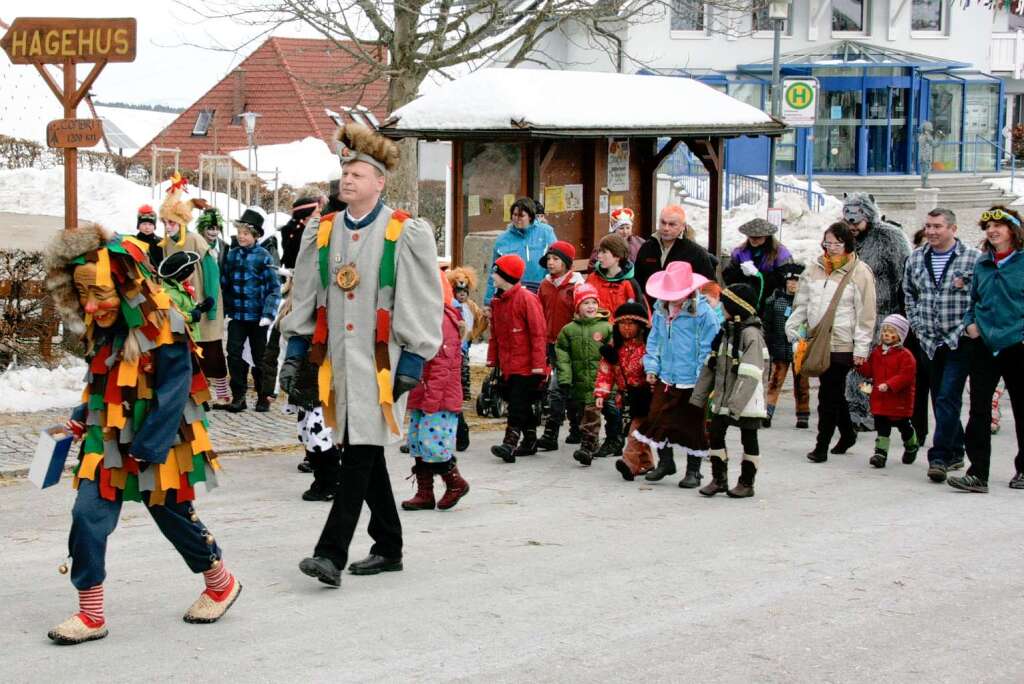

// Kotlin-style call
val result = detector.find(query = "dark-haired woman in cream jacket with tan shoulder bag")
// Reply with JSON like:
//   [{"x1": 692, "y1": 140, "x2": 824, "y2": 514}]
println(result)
[{"x1": 785, "y1": 221, "x2": 876, "y2": 463}]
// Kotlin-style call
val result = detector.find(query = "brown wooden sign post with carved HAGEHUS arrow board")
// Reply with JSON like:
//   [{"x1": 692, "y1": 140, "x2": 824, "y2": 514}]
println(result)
[{"x1": 0, "y1": 17, "x2": 136, "y2": 228}]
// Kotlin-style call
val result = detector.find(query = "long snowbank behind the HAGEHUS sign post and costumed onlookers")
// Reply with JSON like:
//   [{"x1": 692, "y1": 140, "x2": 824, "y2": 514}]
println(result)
[{"x1": 0, "y1": 166, "x2": 289, "y2": 240}]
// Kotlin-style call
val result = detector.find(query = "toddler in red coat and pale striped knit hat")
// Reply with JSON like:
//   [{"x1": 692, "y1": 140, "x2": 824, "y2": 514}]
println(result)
[{"x1": 857, "y1": 313, "x2": 920, "y2": 468}]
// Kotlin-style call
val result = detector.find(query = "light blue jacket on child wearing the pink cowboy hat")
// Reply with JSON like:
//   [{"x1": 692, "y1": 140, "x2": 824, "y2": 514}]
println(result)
[{"x1": 643, "y1": 295, "x2": 721, "y2": 387}]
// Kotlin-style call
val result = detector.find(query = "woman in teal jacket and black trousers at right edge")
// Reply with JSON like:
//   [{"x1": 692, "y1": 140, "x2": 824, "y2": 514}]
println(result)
[{"x1": 946, "y1": 207, "x2": 1024, "y2": 494}]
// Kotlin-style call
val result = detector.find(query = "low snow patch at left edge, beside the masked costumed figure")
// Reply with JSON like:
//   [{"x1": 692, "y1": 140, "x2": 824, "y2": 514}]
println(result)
[{"x1": 0, "y1": 358, "x2": 85, "y2": 414}]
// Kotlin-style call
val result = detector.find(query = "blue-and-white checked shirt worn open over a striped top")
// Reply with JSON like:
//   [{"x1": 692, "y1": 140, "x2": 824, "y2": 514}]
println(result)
[{"x1": 903, "y1": 240, "x2": 981, "y2": 358}]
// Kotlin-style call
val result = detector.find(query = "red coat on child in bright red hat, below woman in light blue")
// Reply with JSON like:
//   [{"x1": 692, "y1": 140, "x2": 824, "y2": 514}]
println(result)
[{"x1": 489, "y1": 284, "x2": 548, "y2": 378}]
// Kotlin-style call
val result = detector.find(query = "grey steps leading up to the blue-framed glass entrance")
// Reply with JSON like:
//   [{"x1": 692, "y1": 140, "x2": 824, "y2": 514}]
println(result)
[{"x1": 814, "y1": 173, "x2": 1024, "y2": 214}]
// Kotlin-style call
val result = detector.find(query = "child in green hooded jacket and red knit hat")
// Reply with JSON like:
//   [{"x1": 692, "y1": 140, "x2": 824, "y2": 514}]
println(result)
[{"x1": 555, "y1": 284, "x2": 611, "y2": 466}]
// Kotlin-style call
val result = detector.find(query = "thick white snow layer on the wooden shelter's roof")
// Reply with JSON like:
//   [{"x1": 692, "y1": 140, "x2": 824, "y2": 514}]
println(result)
[{"x1": 385, "y1": 69, "x2": 783, "y2": 137}]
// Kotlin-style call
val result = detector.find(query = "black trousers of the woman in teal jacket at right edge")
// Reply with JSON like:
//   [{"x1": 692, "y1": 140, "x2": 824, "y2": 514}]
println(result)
[{"x1": 964, "y1": 340, "x2": 1024, "y2": 482}]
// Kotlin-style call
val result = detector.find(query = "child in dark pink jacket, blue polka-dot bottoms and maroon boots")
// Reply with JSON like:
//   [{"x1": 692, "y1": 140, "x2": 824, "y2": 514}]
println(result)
[{"x1": 401, "y1": 274, "x2": 469, "y2": 511}]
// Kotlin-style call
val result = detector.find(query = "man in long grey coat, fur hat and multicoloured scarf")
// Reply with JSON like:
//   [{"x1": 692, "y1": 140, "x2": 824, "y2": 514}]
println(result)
[{"x1": 281, "y1": 124, "x2": 443, "y2": 587}]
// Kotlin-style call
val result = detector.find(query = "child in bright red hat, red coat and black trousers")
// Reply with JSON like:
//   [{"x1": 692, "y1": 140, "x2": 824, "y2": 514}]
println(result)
[{"x1": 487, "y1": 254, "x2": 548, "y2": 463}]
